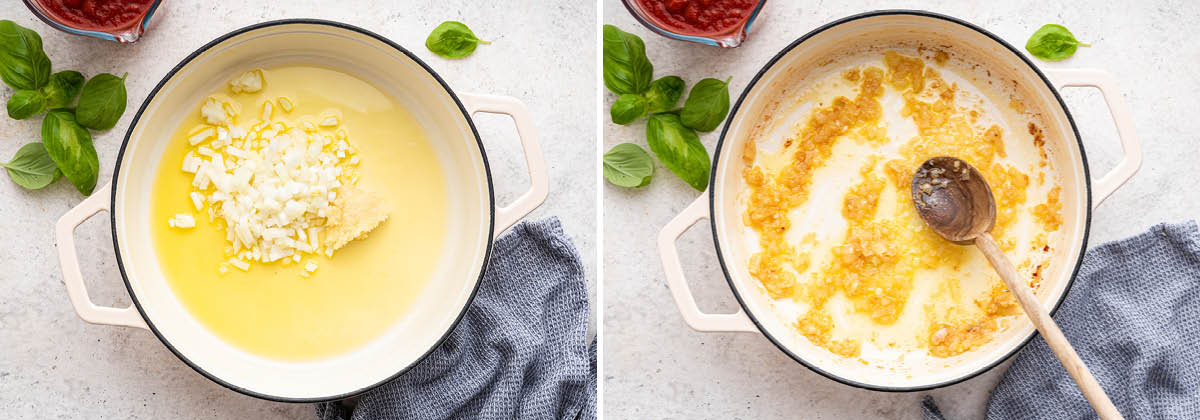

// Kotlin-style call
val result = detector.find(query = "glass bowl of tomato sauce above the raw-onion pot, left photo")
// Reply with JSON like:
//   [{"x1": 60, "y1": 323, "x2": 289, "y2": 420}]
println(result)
[{"x1": 25, "y1": 0, "x2": 162, "y2": 43}]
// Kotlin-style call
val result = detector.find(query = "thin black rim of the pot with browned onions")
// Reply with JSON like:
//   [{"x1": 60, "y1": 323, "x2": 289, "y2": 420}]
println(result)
[{"x1": 708, "y1": 10, "x2": 1092, "y2": 392}]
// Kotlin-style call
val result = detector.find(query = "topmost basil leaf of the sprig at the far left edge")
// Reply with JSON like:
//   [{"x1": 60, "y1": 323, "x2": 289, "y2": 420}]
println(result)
[{"x1": 0, "y1": 20, "x2": 50, "y2": 90}]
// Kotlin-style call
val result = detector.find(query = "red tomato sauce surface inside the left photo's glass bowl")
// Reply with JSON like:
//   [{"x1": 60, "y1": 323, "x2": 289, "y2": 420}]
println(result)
[{"x1": 37, "y1": 0, "x2": 155, "y2": 29}]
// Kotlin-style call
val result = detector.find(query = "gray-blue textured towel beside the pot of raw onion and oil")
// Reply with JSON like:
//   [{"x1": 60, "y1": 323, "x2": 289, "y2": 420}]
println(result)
[{"x1": 317, "y1": 217, "x2": 596, "y2": 420}]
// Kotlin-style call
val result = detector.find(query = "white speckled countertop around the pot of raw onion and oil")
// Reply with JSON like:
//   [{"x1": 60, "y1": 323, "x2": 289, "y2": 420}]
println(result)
[{"x1": 0, "y1": 0, "x2": 596, "y2": 419}]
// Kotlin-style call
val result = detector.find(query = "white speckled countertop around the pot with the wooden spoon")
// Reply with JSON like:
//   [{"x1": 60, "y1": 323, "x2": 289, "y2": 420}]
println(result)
[{"x1": 601, "y1": 0, "x2": 1200, "y2": 419}]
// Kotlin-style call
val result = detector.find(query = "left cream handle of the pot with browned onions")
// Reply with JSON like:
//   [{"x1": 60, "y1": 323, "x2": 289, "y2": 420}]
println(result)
[{"x1": 659, "y1": 194, "x2": 758, "y2": 332}]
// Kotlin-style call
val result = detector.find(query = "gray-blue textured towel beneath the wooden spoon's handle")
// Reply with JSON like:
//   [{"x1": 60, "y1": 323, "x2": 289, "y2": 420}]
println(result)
[{"x1": 922, "y1": 222, "x2": 1200, "y2": 419}]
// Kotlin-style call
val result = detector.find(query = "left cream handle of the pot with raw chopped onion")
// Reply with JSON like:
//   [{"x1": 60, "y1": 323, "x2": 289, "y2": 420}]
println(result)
[{"x1": 54, "y1": 184, "x2": 149, "y2": 330}]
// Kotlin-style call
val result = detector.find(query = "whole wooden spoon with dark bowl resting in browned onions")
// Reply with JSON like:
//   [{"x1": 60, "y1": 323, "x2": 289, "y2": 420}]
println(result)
[{"x1": 912, "y1": 157, "x2": 1122, "y2": 419}]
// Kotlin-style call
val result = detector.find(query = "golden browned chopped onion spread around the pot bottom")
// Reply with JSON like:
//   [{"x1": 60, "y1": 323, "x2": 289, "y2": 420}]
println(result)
[{"x1": 742, "y1": 52, "x2": 1062, "y2": 358}]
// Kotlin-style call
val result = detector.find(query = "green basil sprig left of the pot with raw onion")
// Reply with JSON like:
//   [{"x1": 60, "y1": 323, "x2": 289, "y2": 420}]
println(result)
[{"x1": 0, "y1": 20, "x2": 127, "y2": 196}]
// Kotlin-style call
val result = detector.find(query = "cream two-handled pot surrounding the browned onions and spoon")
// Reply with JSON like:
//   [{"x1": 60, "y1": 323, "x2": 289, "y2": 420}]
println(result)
[{"x1": 659, "y1": 11, "x2": 1141, "y2": 391}]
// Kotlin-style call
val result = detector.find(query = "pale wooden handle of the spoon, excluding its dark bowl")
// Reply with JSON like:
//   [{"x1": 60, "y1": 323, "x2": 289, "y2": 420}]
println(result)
[{"x1": 976, "y1": 233, "x2": 1123, "y2": 419}]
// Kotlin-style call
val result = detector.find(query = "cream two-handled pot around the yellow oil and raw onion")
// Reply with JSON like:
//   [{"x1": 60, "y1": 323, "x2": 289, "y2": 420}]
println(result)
[{"x1": 56, "y1": 19, "x2": 548, "y2": 402}]
